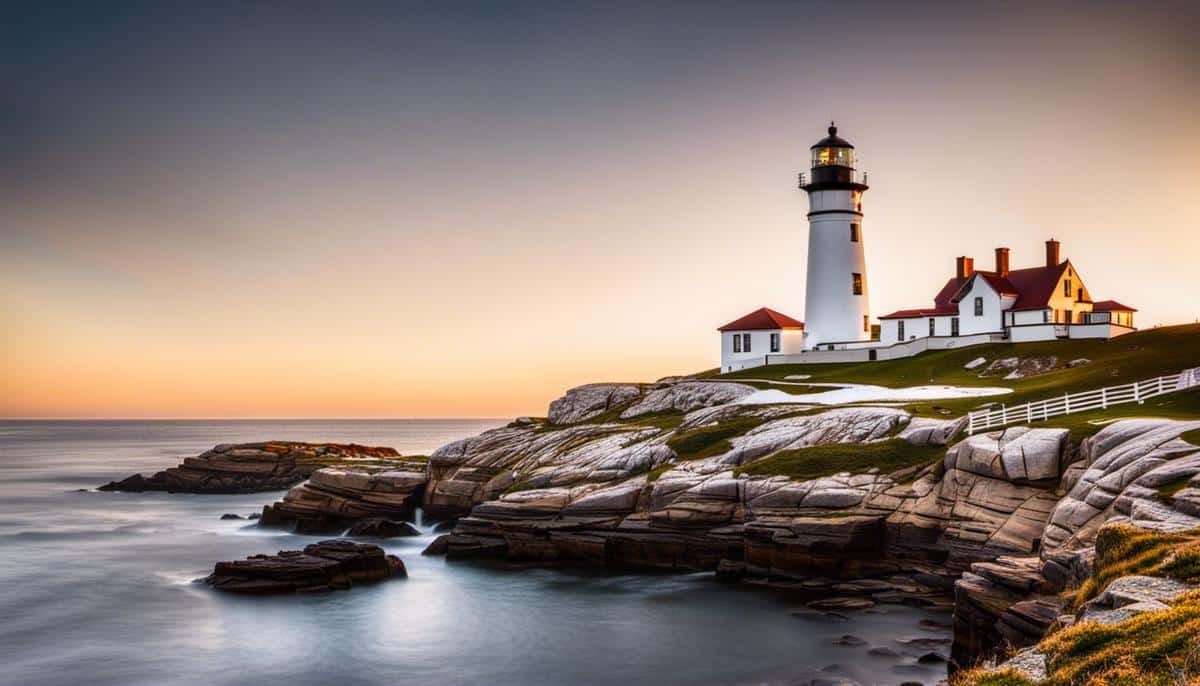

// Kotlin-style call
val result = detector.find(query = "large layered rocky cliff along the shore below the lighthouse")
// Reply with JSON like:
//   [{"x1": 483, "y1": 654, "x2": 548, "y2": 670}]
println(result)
[{"x1": 229, "y1": 380, "x2": 1200, "y2": 667}]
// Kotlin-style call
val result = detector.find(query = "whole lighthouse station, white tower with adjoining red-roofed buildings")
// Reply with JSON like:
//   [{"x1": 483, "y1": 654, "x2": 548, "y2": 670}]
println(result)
[{"x1": 719, "y1": 124, "x2": 1136, "y2": 372}]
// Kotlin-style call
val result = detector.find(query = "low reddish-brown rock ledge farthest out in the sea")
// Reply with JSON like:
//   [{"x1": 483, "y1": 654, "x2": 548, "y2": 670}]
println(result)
[{"x1": 100, "y1": 441, "x2": 400, "y2": 493}]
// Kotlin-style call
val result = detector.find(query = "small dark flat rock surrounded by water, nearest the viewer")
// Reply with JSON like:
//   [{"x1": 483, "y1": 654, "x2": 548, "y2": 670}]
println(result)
[{"x1": 203, "y1": 541, "x2": 408, "y2": 595}]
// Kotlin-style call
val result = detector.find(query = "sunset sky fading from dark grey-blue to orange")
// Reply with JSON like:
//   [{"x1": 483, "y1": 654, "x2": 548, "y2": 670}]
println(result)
[{"x1": 0, "y1": 1, "x2": 1200, "y2": 417}]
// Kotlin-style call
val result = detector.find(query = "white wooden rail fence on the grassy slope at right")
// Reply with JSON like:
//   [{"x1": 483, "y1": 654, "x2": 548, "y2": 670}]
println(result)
[{"x1": 967, "y1": 367, "x2": 1200, "y2": 434}]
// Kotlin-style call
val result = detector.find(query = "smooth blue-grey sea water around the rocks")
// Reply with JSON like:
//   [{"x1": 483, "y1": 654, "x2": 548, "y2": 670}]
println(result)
[{"x1": 0, "y1": 420, "x2": 948, "y2": 686}]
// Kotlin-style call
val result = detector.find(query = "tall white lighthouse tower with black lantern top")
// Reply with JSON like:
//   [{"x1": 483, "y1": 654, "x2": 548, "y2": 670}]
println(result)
[{"x1": 800, "y1": 122, "x2": 871, "y2": 350}]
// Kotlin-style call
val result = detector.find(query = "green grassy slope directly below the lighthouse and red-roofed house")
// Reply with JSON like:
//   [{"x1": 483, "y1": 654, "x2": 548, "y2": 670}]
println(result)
[{"x1": 716, "y1": 324, "x2": 1200, "y2": 414}]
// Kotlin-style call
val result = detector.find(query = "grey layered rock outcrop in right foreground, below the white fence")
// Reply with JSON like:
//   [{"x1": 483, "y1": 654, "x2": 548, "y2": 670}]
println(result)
[{"x1": 954, "y1": 420, "x2": 1200, "y2": 680}]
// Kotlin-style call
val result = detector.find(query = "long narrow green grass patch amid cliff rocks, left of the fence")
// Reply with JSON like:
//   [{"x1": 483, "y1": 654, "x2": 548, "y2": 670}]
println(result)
[{"x1": 734, "y1": 439, "x2": 946, "y2": 480}]
